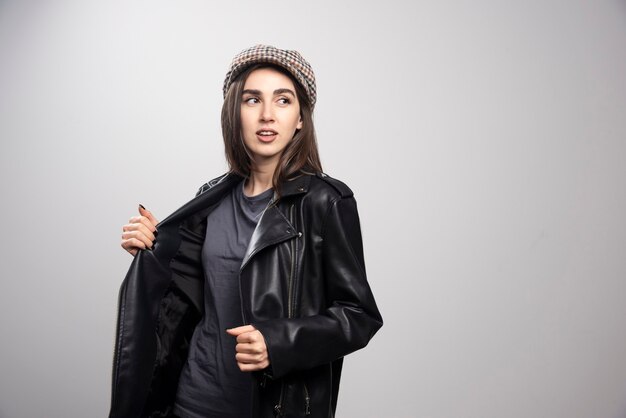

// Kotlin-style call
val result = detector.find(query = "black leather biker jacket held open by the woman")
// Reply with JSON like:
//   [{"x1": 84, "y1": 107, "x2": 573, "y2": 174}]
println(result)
[{"x1": 110, "y1": 174, "x2": 382, "y2": 418}]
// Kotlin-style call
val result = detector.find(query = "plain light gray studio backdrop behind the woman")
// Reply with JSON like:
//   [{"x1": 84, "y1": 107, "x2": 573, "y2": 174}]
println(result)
[{"x1": 0, "y1": 0, "x2": 626, "y2": 418}]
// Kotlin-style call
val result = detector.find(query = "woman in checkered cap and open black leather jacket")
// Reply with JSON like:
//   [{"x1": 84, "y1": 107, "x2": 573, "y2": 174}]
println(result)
[{"x1": 110, "y1": 45, "x2": 382, "y2": 418}]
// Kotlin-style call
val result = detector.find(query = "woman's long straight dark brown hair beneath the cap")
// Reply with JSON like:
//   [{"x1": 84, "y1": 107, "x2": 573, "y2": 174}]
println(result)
[{"x1": 222, "y1": 64, "x2": 322, "y2": 197}]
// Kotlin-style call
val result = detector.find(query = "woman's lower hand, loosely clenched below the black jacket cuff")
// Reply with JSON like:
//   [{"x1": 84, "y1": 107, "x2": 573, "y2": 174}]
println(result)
[{"x1": 226, "y1": 325, "x2": 270, "y2": 372}]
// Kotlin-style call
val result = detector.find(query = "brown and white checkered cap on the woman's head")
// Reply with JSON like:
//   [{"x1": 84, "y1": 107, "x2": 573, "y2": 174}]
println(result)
[{"x1": 224, "y1": 45, "x2": 317, "y2": 107}]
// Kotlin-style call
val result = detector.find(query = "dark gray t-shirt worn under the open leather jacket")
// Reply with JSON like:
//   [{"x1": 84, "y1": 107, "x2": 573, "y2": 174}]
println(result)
[{"x1": 174, "y1": 182, "x2": 273, "y2": 418}]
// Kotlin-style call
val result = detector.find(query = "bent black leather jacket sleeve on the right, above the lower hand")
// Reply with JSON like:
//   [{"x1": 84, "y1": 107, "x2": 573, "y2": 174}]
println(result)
[{"x1": 253, "y1": 196, "x2": 383, "y2": 378}]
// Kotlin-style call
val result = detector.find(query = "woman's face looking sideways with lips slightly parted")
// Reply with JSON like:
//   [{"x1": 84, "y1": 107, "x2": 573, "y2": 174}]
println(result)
[{"x1": 241, "y1": 68, "x2": 302, "y2": 169}]
